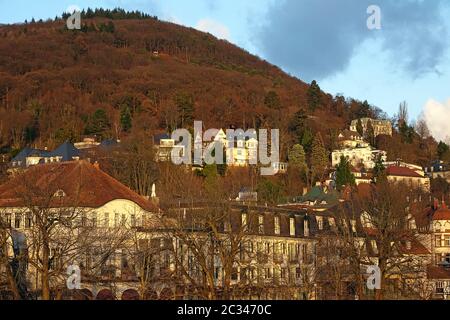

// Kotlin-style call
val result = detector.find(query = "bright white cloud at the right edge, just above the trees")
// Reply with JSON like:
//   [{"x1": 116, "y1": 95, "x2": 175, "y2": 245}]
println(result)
[{"x1": 423, "y1": 99, "x2": 450, "y2": 141}]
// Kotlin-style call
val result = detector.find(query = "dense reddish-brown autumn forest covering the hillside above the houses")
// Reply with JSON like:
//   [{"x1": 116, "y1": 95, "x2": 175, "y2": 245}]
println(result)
[{"x1": 0, "y1": 9, "x2": 444, "y2": 168}]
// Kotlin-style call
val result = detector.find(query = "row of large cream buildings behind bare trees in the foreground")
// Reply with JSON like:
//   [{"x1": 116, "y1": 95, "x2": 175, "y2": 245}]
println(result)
[{"x1": 0, "y1": 160, "x2": 450, "y2": 299}]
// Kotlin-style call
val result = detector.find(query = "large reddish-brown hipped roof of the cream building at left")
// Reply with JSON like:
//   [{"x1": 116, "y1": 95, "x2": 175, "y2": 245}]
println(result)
[{"x1": 0, "y1": 161, "x2": 158, "y2": 212}]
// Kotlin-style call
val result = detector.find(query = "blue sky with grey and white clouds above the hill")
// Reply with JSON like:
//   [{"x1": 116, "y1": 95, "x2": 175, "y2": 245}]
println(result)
[{"x1": 0, "y1": 0, "x2": 450, "y2": 140}]
